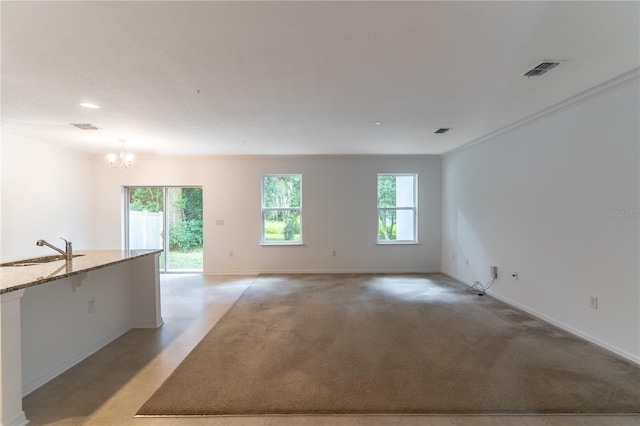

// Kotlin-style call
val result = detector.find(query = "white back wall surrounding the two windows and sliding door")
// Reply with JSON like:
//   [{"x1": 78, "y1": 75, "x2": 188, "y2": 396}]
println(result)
[{"x1": 93, "y1": 156, "x2": 442, "y2": 273}]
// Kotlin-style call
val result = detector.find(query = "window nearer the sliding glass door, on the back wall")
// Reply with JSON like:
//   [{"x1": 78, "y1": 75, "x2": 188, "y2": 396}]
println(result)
[{"x1": 262, "y1": 175, "x2": 302, "y2": 244}]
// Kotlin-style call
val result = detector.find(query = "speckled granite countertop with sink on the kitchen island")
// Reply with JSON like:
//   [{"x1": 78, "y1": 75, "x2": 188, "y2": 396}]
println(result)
[{"x1": 0, "y1": 249, "x2": 162, "y2": 294}]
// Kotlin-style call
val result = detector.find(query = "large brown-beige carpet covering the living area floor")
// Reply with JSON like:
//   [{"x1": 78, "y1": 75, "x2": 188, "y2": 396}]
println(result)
[{"x1": 138, "y1": 274, "x2": 640, "y2": 416}]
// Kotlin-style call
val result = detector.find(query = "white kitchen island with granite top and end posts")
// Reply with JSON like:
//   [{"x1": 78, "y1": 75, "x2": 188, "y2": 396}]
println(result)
[{"x1": 0, "y1": 250, "x2": 163, "y2": 426}]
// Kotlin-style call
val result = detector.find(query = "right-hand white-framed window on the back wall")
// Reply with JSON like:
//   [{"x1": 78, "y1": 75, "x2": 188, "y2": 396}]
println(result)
[{"x1": 378, "y1": 173, "x2": 418, "y2": 244}]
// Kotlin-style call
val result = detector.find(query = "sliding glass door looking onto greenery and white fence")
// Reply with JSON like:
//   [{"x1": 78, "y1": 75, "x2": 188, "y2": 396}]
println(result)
[{"x1": 125, "y1": 186, "x2": 203, "y2": 272}]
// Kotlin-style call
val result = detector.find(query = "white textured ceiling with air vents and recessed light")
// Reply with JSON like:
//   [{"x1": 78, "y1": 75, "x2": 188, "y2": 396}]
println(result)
[{"x1": 1, "y1": 1, "x2": 640, "y2": 155}]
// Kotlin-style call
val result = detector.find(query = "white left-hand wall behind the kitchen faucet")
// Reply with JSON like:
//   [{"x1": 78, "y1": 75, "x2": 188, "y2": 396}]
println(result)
[{"x1": 0, "y1": 132, "x2": 93, "y2": 261}]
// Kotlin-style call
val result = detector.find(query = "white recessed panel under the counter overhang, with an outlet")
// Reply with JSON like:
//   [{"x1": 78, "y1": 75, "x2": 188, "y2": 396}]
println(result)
[{"x1": 20, "y1": 262, "x2": 134, "y2": 395}]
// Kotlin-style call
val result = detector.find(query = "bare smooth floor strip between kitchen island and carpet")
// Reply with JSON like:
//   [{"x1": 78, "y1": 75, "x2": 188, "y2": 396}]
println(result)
[{"x1": 23, "y1": 275, "x2": 640, "y2": 426}]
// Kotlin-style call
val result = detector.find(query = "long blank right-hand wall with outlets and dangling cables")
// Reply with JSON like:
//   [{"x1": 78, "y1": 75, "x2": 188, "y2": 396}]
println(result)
[{"x1": 443, "y1": 78, "x2": 640, "y2": 362}]
